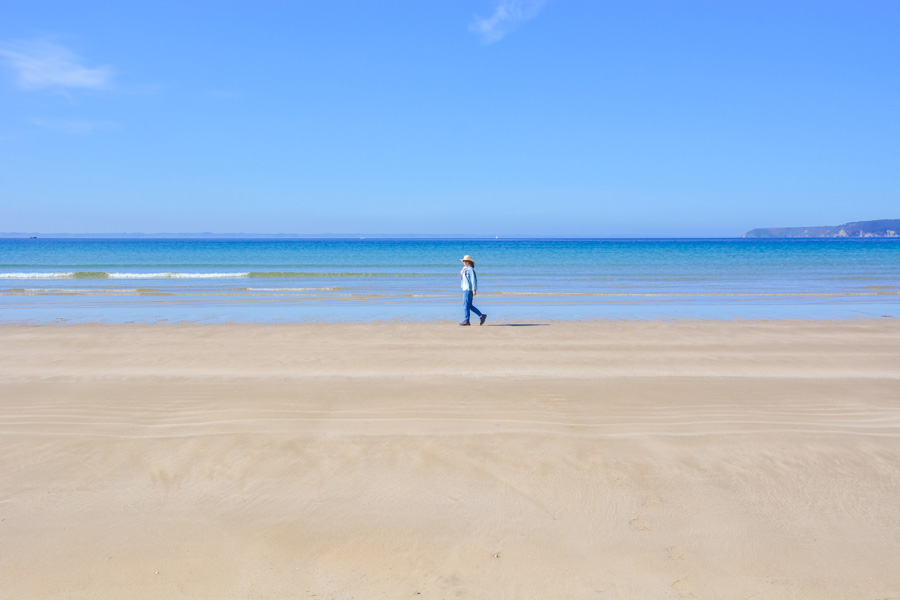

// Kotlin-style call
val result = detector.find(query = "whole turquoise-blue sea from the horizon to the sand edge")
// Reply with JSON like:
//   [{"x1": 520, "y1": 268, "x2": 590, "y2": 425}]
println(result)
[{"x1": 0, "y1": 239, "x2": 900, "y2": 323}]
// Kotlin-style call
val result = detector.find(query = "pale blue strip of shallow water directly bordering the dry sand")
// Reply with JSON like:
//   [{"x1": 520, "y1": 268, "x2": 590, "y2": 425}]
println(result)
[{"x1": 0, "y1": 304, "x2": 900, "y2": 327}]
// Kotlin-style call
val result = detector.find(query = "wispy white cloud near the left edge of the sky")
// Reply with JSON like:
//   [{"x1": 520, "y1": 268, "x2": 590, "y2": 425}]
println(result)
[{"x1": 0, "y1": 40, "x2": 113, "y2": 90}]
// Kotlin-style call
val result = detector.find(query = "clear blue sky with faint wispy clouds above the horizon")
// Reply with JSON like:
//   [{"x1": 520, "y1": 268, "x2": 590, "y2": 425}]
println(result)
[{"x1": 0, "y1": 0, "x2": 900, "y2": 237}]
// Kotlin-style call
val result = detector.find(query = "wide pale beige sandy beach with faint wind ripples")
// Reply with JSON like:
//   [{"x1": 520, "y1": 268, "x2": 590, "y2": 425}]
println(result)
[{"x1": 0, "y1": 319, "x2": 900, "y2": 600}]
